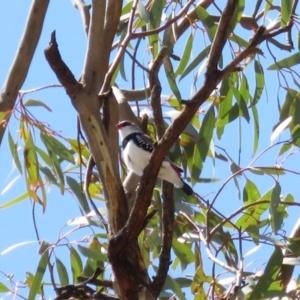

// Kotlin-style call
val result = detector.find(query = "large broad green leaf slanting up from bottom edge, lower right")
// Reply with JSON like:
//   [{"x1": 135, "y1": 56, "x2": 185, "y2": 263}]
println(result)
[{"x1": 249, "y1": 247, "x2": 283, "y2": 300}]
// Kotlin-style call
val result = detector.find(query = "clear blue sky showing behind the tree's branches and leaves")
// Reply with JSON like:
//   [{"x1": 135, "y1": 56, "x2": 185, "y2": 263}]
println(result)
[{"x1": 0, "y1": 0, "x2": 299, "y2": 295}]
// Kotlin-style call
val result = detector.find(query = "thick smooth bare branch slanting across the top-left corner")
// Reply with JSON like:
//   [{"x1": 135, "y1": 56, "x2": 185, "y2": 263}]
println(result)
[{"x1": 0, "y1": 0, "x2": 49, "y2": 145}]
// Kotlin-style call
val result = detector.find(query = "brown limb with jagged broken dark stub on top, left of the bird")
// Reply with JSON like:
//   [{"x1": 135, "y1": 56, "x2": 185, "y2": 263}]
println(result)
[{"x1": 45, "y1": 33, "x2": 128, "y2": 236}]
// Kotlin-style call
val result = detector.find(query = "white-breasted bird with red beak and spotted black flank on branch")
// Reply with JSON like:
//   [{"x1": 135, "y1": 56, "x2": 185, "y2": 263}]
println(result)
[{"x1": 116, "y1": 121, "x2": 194, "y2": 196}]
